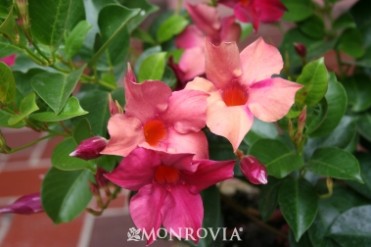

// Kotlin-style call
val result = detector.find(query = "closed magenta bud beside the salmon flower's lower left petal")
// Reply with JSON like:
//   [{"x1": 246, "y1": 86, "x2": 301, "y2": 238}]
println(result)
[{"x1": 70, "y1": 136, "x2": 108, "y2": 160}]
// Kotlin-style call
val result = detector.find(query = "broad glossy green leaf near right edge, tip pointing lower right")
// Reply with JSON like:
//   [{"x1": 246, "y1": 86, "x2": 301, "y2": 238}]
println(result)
[{"x1": 308, "y1": 147, "x2": 362, "y2": 183}]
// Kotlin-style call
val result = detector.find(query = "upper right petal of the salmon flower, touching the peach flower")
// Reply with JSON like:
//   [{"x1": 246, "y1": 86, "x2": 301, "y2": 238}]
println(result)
[{"x1": 162, "y1": 90, "x2": 209, "y2": 134}]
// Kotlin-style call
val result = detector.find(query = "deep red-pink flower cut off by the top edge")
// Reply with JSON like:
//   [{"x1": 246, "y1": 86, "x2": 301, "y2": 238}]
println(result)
[{"x1": 219, "y1": 0, "x2": 286, "y2": 30}]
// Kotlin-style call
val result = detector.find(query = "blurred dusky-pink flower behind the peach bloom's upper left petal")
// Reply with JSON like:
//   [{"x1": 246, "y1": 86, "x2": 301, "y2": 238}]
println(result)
[{"x1": 175, "y1": 4, "x2": 241, "y2": 83}]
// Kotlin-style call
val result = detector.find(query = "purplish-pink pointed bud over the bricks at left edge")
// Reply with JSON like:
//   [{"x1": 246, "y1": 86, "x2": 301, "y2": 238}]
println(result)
[{"x1": 0, "y1": 193, "x2": 44, "y2": 214}]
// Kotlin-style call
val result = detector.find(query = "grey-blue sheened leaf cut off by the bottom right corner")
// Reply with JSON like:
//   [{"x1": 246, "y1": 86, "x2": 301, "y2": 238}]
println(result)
[{"x1": 329, "y1": 205, "x2": 371, "y2": 247}]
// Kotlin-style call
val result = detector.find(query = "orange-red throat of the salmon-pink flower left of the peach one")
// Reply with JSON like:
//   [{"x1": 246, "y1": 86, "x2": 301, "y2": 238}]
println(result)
[{"x1": 143, "y1": 119, "x2": 167, "y2": 146}]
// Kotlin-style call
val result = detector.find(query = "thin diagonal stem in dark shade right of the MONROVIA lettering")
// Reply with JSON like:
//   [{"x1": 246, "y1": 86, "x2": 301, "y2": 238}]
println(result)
[{"x1": 221, "y1": 195, "x2": 287, "y2": 239}]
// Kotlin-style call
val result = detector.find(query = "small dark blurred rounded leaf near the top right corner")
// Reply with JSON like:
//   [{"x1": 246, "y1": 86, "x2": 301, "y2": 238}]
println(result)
[{"x1": 338, "y1": 28, "x2": 365, "y2": 58}]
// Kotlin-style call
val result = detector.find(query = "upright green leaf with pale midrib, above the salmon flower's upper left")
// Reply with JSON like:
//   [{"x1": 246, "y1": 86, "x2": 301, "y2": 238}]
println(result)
[{"x1": 91, "y1": 4, "x2": 140, "y2": 64}]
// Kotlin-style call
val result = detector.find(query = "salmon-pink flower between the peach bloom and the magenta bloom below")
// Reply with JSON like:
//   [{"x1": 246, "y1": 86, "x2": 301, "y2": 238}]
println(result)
[{"x1": 102, "y1": 67, "x2": 208, "y2": 158}]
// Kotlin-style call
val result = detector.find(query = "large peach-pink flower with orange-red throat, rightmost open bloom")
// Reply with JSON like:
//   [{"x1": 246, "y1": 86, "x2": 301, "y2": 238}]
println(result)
[{"x1": 186, "y1": 39, "x2": 301, "y2": 150}]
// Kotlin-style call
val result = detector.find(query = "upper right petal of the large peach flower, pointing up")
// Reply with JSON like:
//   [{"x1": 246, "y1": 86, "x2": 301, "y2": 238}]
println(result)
[{"x1": 240, "y1": 38, "x2": 283, "y2": 85}]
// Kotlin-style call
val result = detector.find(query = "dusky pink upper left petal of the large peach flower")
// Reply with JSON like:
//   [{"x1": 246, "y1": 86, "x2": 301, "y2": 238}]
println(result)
[{"x1": 205, "y1": 41, "x2": 242, "y2": 89}]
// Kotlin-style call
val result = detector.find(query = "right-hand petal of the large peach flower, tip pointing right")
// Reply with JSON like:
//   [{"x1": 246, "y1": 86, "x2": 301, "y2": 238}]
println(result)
[{"x1": 247, "y1": 78, "x2": 302, "y2": 122}]
